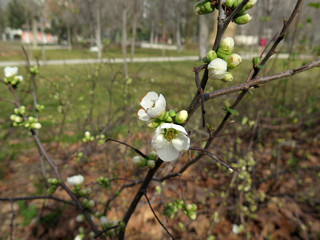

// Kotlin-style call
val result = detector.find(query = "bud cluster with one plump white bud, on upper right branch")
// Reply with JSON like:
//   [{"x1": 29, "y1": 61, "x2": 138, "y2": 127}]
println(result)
[{"x1": 203, "y1": 37, "x2": 242, "y2": 82}]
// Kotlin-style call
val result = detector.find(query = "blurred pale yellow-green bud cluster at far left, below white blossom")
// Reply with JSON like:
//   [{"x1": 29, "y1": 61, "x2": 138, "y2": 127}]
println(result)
[{"x1": 10, "y1": 106, "x2": 41, "y2": 129}]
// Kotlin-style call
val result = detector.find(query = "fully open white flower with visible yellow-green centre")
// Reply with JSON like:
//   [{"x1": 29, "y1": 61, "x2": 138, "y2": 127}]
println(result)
[{"x1": 152, "y1": 123, "x2": 190, "y2": 162}]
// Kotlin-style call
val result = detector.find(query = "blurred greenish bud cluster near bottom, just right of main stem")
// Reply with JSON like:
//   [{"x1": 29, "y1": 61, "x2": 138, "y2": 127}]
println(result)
[{"x1": 163, "y1": 199, "x2": 197, "y2": 220}]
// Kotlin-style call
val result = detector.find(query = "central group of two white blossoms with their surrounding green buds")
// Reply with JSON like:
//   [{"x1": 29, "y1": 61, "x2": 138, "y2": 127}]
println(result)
[{"x1": 134, "y1": 92, "x2": 190, "y2": 161}]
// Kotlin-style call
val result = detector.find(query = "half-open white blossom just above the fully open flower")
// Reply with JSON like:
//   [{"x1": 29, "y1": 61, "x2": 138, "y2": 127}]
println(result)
[{"x1": 137, "y1": 92, "x2": 166, "y2": 122}]
